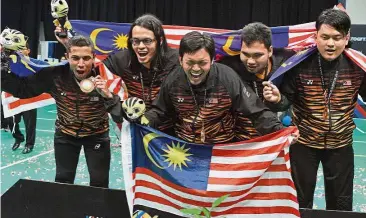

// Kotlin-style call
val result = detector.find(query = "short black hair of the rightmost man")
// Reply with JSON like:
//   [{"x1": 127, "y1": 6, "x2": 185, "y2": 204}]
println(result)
[{"x1": 315, "y1": 8, "x2": 351, "y2": 36}]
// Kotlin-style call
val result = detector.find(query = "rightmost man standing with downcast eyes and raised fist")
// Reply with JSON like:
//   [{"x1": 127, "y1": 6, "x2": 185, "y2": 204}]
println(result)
[{"x1": 264, "y1": 9, "x2": 366, "y2": 211}]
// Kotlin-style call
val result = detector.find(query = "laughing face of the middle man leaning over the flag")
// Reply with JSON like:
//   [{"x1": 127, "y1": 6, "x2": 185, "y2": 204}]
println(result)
[{"x1": 179, "y1": 48, "x2": 211, "y2": 85}]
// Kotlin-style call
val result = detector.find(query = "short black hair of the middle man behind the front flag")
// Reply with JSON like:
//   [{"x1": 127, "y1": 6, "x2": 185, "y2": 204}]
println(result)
[{"x1": 179, "y1": 31, "x2": 215, "y2": 60}]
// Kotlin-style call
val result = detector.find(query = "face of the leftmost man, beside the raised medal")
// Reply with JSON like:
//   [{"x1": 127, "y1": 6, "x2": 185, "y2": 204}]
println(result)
[{"x1": 66, "y1": 46, "x2": 94, "y2": 80}]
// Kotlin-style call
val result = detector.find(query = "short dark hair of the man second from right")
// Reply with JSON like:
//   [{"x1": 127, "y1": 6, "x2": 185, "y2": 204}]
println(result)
[{"x1": 241, "y1": 22, "x2": 272, "y2": 50}]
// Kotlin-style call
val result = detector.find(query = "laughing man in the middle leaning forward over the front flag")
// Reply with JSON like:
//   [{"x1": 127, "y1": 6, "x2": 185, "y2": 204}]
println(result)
[{"x1": 129, "y1": 31, "x2": 283, "y2": 144}]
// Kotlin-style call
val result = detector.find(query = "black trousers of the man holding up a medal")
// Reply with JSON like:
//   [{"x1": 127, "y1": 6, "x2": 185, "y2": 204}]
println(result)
[{"x1": 54, "y1": 130, "x2": 111, "y2": 188}]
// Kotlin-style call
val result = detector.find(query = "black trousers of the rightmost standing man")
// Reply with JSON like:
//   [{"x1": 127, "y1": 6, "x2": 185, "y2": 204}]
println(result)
[{"x1": 290, "y1": 143, "x2": 354, "y2": 211}]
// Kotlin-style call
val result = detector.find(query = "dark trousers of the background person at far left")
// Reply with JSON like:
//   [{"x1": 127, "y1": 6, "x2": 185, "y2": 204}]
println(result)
[{"x1": 9, "y1": 109, "x2": 37, "y2": 148}]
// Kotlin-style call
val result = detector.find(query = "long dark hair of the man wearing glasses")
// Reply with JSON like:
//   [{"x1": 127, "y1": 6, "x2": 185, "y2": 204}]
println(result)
[{"x1": 127, "y1": 14, "x2": 168, "y2": 71}]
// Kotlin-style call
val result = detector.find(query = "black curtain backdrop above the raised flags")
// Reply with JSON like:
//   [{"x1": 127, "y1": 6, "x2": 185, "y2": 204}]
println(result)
[{"x1": 1, "y1": 0, "x2": 338, "y2": 57}]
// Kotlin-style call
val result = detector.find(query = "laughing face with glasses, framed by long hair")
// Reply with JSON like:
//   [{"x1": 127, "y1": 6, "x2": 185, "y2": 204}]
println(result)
[{"x1": 130, "y1": 26, "x2": 157, "y2": 69}]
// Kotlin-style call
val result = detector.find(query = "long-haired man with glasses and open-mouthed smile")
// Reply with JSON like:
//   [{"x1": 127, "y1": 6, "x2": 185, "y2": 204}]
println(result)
[{"x1": 55, "y1": 14, "x2": 179, "y2": 134}]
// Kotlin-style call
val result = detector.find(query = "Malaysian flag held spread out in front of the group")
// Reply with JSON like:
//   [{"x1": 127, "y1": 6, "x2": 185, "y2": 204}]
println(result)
[{"x1": 122, "y1": 122, "x2": 299, "y2": 218}]
